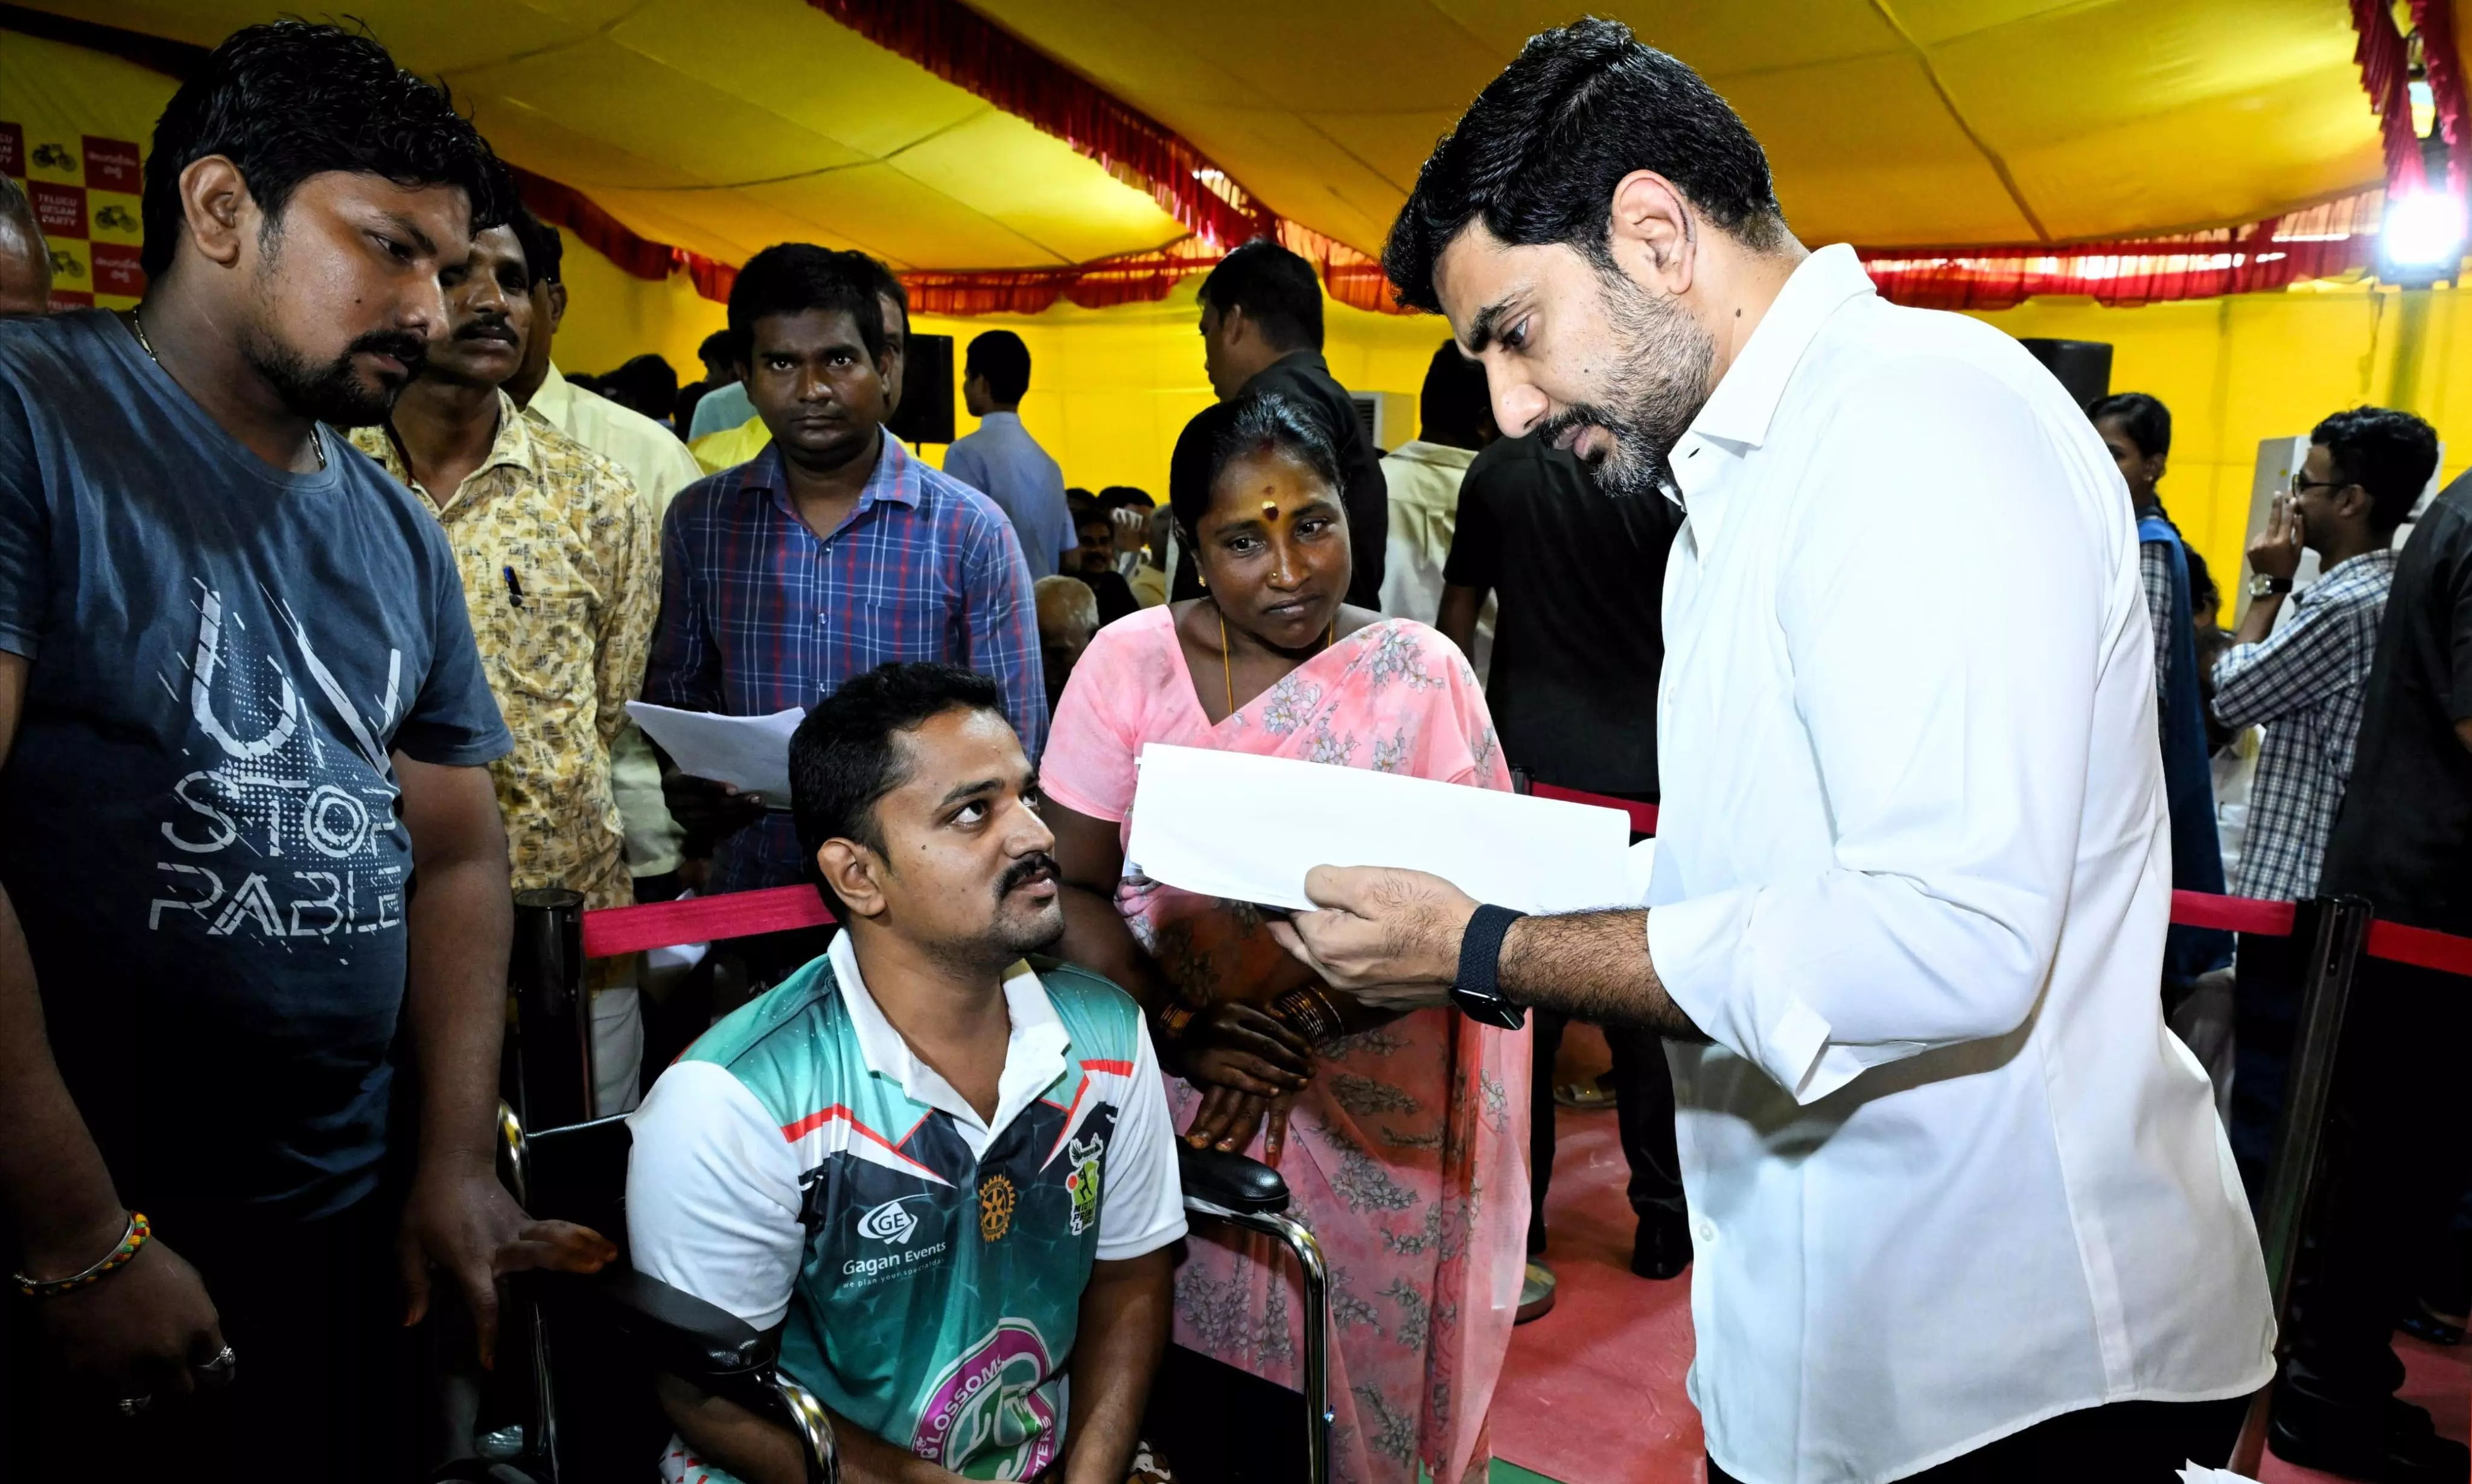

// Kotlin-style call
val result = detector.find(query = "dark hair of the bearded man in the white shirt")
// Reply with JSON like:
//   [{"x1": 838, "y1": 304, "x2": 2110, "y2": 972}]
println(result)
[{"x1": 1382, "y1": 20, "x2": 1790, "y2": 309}]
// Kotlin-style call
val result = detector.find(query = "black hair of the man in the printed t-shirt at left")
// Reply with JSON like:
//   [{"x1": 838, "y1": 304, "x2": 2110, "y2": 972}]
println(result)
[{"x1": 138, "y1": 20, "x2": 517, "y2": 277}]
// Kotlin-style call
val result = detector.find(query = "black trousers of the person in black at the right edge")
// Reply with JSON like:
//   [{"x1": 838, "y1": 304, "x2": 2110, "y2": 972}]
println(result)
[{"x1": 2276, "y1": 960, "x2": 2472, "y2": 1427}]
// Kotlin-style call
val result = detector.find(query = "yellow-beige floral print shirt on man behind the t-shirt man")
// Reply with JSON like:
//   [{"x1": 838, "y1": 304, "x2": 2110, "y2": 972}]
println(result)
[{"x1": 351, "y1": 393, "x2": 660, "y2": 908}]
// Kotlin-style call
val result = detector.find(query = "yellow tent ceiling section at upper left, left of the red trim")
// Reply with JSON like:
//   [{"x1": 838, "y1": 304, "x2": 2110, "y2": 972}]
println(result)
[{"x1": 10, "y1": 0, "x2": 1184, "y2": 267}]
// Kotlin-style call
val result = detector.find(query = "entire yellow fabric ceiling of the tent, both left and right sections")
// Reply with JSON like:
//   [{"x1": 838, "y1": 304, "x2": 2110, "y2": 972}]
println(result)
[{"x1": 14, "y1": 0, "x2": 2412, "y2": 267}]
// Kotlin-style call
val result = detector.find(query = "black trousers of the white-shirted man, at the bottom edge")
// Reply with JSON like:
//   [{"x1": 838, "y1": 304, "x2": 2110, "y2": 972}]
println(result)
[{"x1": 1708, "y1": 1398, "x2": 2249, "y2": 1484}]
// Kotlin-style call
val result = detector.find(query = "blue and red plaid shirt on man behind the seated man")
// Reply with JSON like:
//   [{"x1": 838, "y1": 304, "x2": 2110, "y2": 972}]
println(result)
[{"x1": 643, "y1": 438, "x2": 1048, "y2": 893}]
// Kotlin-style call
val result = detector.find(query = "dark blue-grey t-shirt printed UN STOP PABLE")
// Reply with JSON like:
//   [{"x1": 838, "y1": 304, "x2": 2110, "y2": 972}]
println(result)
[{"x1": 0, "y1": 311, "x2": 507, "y2": 1217}]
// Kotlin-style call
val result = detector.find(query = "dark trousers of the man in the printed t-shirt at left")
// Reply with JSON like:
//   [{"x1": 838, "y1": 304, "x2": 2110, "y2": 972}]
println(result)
[{"x1": 0, "y1": 1197, "x2": 415, "y2": 1484}]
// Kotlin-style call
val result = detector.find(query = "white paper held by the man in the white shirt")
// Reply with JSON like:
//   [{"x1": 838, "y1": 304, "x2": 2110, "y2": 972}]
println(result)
[{"x1": 1125, "y1": 745, "x2": 1644, "y2": 912}]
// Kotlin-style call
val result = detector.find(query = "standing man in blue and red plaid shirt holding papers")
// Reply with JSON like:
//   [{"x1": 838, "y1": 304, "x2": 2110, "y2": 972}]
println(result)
[{"x1": 643, "y1": 243, "x2": 1048, "y2": 890}]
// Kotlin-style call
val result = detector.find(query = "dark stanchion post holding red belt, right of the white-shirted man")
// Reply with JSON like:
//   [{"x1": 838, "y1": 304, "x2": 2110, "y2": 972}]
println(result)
[{"x1": 2232, "y1": 898, "x2": 2373, "y2": 1477}]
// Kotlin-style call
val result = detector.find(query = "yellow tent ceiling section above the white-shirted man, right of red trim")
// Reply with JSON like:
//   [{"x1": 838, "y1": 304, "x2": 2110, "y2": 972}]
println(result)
[{"x1": 974, "y1": 0, "x2": 2383, "y2": 247}]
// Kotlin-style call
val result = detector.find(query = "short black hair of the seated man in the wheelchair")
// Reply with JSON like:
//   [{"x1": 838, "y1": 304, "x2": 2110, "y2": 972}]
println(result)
[{"x1": 789, "y1": 663, "x2": 1004, "y2": 923}]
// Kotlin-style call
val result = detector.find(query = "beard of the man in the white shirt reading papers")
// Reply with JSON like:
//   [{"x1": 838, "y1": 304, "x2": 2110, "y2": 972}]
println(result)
[{"x1": 1535, "y1": 270, "x2": 1716, "y2": 497}]
